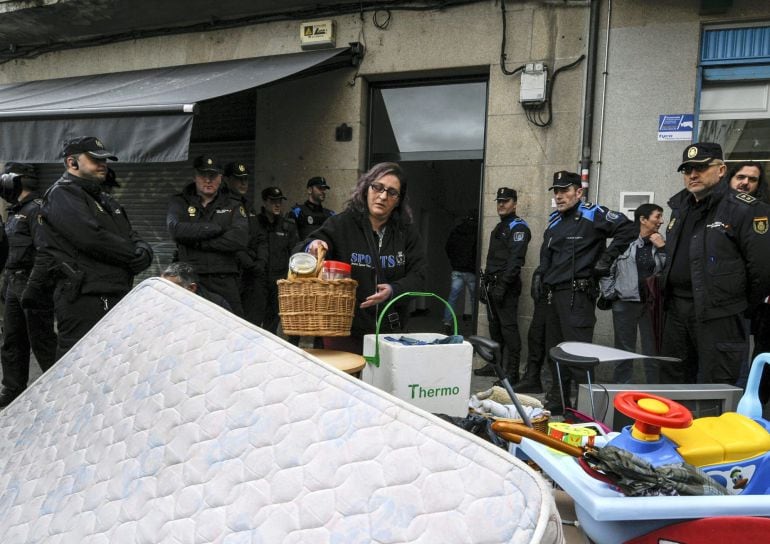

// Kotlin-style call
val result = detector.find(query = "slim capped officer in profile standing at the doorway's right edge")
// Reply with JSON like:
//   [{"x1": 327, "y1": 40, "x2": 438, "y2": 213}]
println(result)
[{"x1": 474, "y1": 187, "x2": 532, "y2": 384}]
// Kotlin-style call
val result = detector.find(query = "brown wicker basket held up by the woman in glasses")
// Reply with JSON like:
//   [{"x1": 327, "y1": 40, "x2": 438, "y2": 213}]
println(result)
[{"x1": 277, "y1": 278, "x2": 358, "y2": 336}]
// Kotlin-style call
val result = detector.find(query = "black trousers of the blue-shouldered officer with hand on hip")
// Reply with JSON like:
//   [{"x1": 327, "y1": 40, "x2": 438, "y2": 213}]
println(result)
[{"x1": 545, "y1": 289, "x2": 596, "y2": 406}]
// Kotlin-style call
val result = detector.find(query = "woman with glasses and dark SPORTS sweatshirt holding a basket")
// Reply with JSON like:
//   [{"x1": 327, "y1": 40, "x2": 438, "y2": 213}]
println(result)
[{"x1": 301, "y1": 162, "x2": 426, "y2": 354}]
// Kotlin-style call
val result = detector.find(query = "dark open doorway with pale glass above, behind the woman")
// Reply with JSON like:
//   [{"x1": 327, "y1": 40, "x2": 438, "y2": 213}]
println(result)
[{"x1": 368, "y1": 78, "x2": 487, "y2": 335}]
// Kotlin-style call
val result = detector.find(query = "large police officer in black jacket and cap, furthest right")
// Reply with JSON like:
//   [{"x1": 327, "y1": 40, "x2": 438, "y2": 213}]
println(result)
[{"x1": 660, "y1": 142, "x2": 770, "y2": 384}]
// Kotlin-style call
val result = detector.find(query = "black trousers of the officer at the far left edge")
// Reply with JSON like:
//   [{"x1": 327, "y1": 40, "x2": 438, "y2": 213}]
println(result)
[{"x1": 0, "y1": 285, "x2": 56, "y2": 393}]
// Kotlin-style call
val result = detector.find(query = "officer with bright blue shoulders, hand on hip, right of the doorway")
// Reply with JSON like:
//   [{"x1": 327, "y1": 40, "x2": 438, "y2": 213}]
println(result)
[{"x1": 532, "y1": 171, "x2": 637, "y2": 413}]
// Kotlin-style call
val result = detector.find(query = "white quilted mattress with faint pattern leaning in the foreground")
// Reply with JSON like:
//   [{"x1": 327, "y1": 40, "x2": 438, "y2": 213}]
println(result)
[{"x1": 0, "y1": 278, "x2": 562, "y2": 544}]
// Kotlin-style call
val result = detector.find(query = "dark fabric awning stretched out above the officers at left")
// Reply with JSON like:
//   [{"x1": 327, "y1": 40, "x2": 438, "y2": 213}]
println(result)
[{"x1": 0, "y1": 48, "x2": 354, "y2": 163}]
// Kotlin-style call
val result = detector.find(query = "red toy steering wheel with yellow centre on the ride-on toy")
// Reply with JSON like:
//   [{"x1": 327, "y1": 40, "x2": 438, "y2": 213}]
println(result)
[{"x1": 614, "y1": 391, "x2": 692, "y2": 441}]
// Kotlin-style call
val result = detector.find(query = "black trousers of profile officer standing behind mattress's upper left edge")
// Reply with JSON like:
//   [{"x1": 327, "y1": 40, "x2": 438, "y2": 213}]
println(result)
[{"x1": 53, "y1": 280, "x2": 126, "y2": 360}]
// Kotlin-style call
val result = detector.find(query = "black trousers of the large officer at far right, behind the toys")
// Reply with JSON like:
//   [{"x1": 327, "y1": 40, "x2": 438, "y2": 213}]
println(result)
[{"x1": 659, "y1": 296, "x2": 749, "y2": 385}]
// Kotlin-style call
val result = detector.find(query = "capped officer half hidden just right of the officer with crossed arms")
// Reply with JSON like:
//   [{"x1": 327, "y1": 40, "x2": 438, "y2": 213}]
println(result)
[{"x1": 225, "y1": 162, "x2": 267, "y2": 325}]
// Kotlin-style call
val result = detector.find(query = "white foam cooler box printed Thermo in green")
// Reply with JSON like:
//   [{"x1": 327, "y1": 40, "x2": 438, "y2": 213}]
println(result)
[{"x1": 361, "y1": 333, "x2": 473, "y2": 417}]
